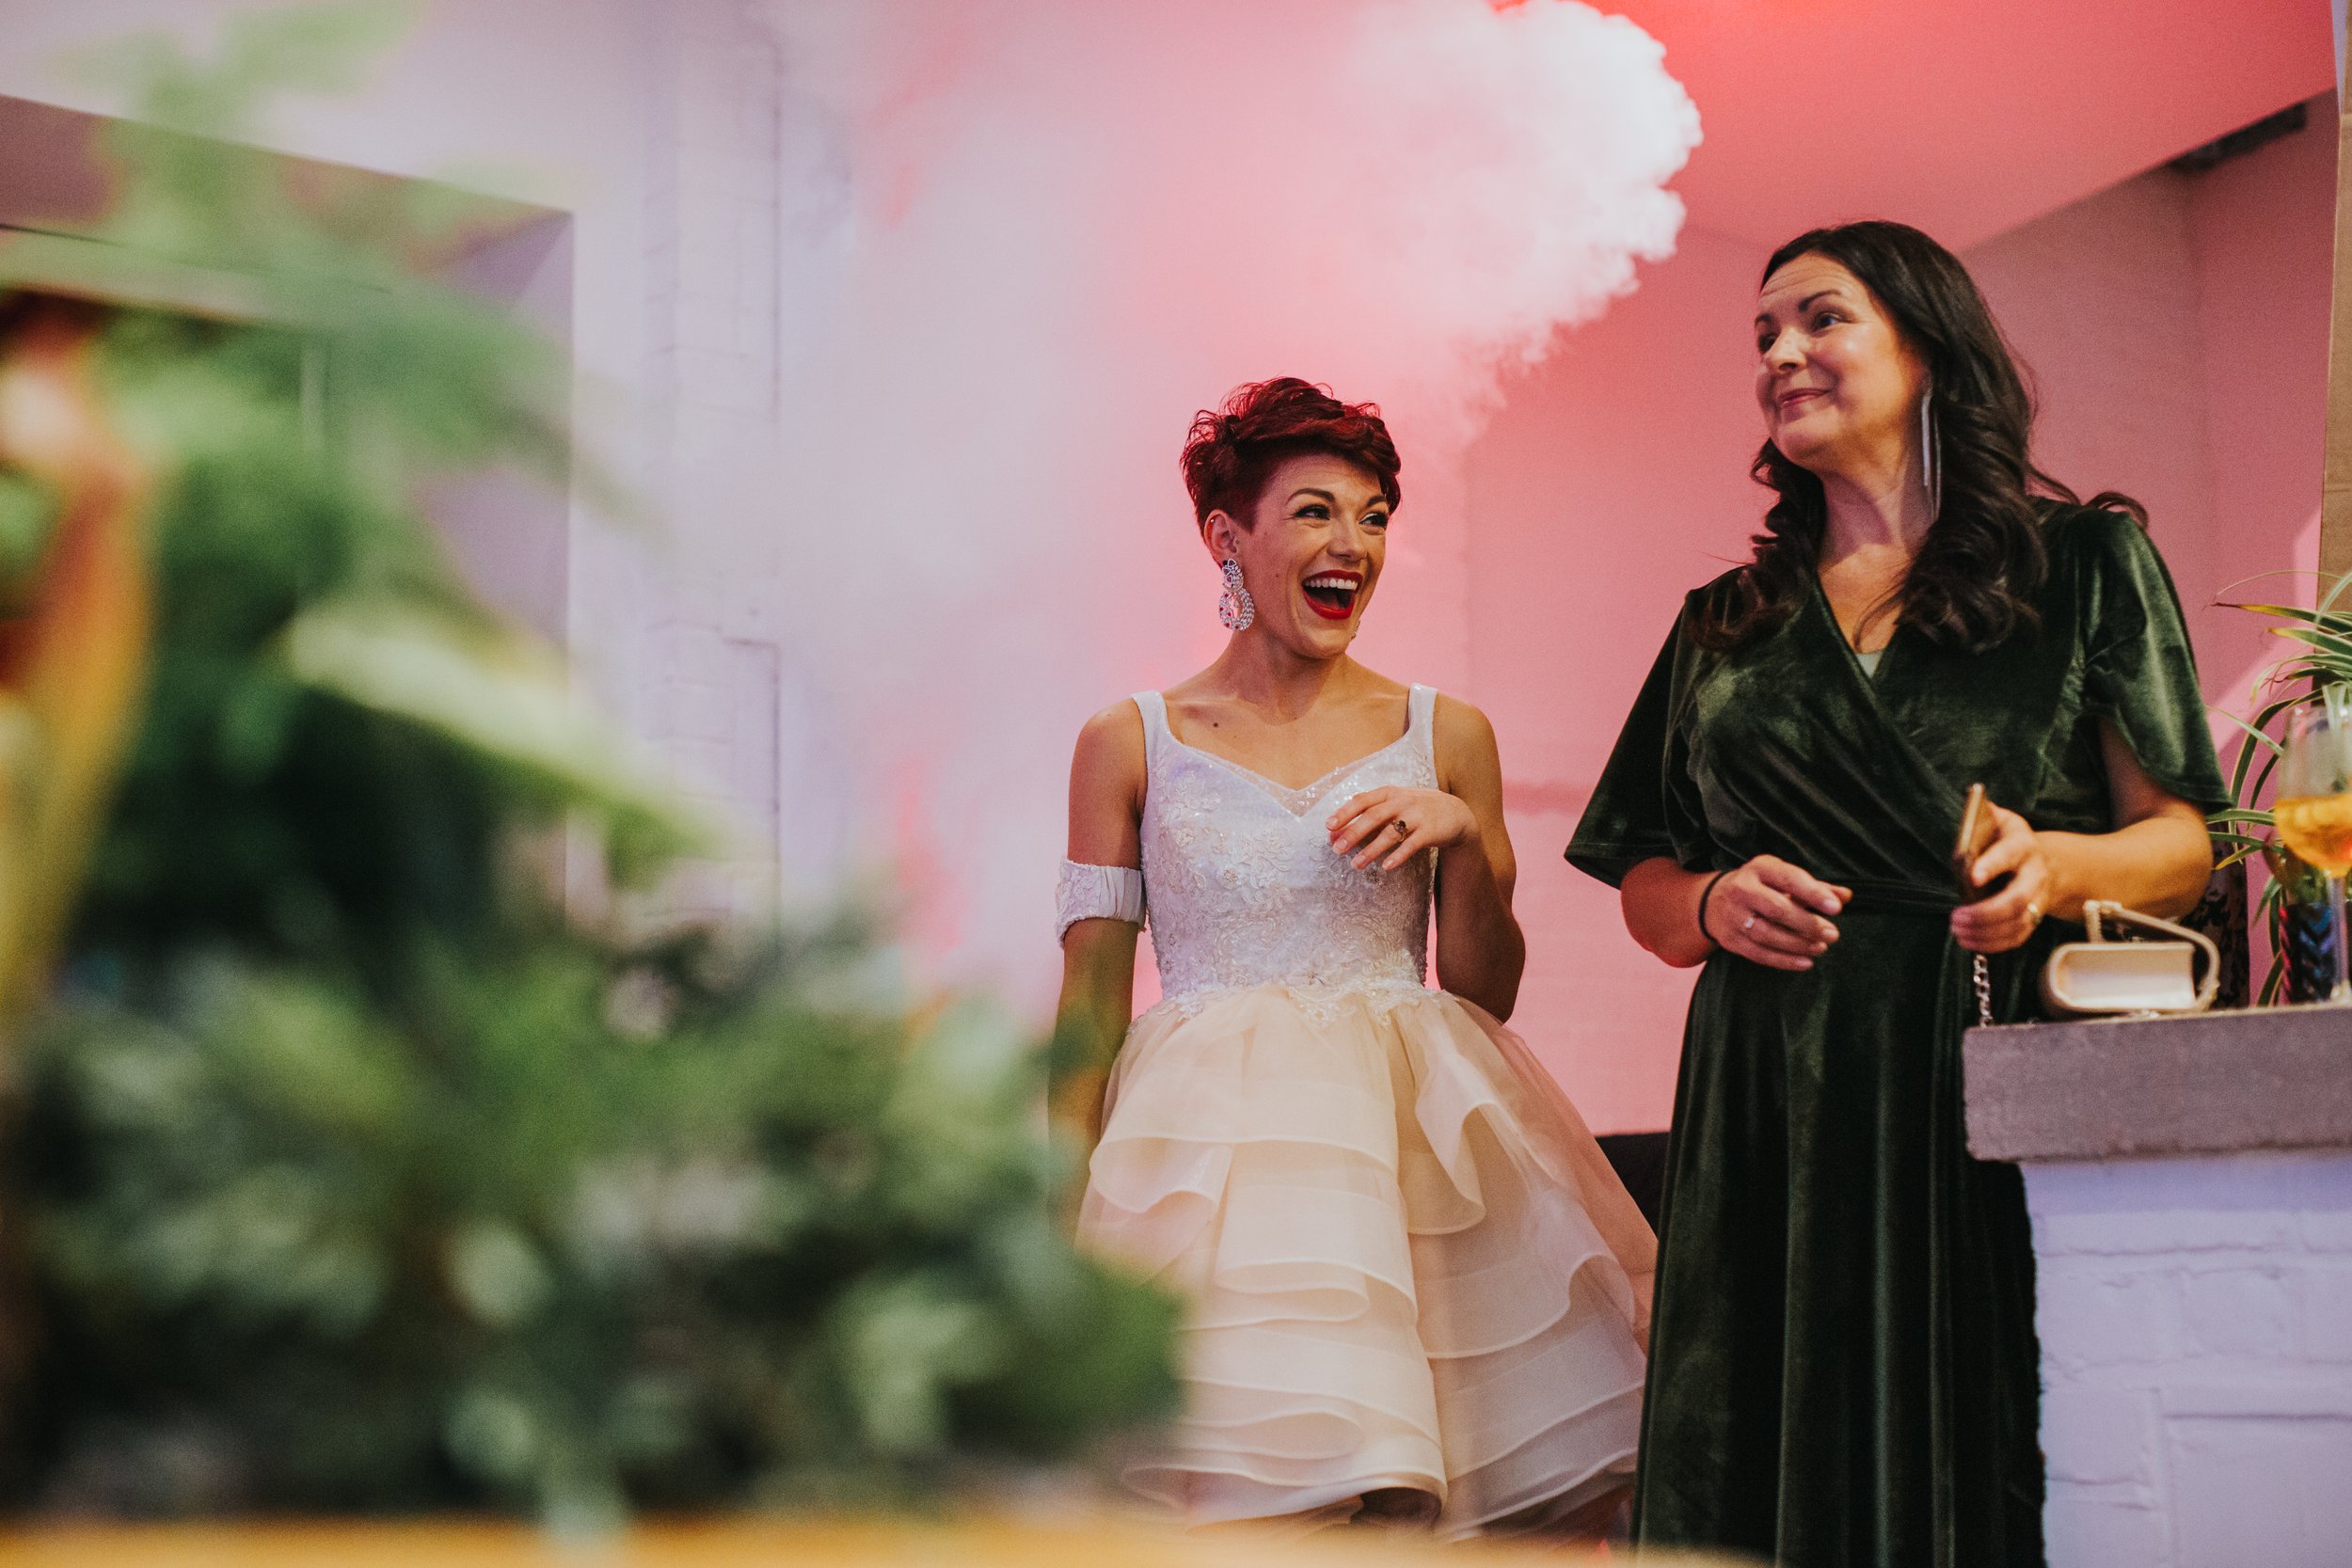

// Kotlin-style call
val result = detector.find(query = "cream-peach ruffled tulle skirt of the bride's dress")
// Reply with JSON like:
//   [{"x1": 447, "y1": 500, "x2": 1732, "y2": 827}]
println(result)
[{"x1": 1080, "y1": 985, "x2": 1656, "y2": 1535}]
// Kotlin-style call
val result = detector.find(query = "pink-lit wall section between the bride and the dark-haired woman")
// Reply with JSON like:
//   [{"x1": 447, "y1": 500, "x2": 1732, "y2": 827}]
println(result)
[{"x1": 1468, "y1": 220, "x2": 1769, "y2": 1131}]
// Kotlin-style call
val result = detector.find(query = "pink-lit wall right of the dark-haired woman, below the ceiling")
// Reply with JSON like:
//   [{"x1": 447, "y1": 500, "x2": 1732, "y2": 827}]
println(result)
[{"x1": 1969, "y1": 94, "x2": 2336, "y2": 710}]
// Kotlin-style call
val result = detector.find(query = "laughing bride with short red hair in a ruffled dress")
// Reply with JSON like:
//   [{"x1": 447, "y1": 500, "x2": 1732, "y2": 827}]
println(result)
[{"x1": 1054, "y1": 378, "x2": 1654, "y2": 1535}]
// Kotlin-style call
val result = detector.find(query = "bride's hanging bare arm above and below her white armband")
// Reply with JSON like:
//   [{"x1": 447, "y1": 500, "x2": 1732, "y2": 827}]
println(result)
[{"x1": 1049, "y1": 703, "x2": 1143, "y2": 1149}]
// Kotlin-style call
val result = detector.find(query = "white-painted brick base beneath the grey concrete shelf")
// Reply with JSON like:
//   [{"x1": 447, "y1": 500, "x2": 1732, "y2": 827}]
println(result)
[{"x1": 2026, "y1": 1152, "x2": 2352, "y2": 1568}]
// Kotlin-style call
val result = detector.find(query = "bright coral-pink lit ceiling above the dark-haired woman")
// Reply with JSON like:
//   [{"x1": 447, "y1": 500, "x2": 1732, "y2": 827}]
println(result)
[{"x1": 1602, "y1": 0, "x2": 2336, "y2": 249}]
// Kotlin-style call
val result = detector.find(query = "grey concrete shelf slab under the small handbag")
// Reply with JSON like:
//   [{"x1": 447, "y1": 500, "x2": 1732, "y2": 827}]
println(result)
[{"x1": 1964, "y1": 1006, "x2": 2352, "y2": 1162}]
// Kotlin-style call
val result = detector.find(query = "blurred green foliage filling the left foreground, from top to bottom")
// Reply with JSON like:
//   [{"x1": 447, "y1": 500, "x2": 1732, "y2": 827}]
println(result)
[{"x1": 0, "y1": 7, "x2": 1174, "y2": 1526}]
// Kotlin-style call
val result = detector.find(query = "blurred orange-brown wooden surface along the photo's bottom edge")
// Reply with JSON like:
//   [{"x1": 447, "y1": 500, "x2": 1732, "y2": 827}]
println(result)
[{"x1": 0, "y1": 1521, "x2": 1736, "y2": 1568}]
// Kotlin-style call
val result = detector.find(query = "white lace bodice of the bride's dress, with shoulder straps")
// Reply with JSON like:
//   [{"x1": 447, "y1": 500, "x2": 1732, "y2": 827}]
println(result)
[{"x1": 1136, "y1": 687, "x2": 1438, "y2": 1008}]
